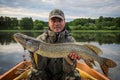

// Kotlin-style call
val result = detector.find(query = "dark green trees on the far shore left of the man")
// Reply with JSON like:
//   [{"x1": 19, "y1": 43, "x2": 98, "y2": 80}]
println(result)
[{"x1": 0, "y1": 16, "x2": 47, "y2": 30}]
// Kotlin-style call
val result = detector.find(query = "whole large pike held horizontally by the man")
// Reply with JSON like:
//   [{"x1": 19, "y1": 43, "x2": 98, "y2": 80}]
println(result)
[{"x1": 13, "y1": 33, "x2": 116, "y2": 76}]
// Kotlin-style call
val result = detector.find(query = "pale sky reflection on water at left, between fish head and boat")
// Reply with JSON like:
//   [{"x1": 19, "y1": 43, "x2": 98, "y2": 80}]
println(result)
[{"x1": 0, "y1": 43, "x2": 29, "y2": 75}]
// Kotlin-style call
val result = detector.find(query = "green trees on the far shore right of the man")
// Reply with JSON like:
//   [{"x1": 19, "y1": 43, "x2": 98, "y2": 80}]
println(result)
[{"x1": 68, "y1": 16, "x2": 120, "y2": 30}]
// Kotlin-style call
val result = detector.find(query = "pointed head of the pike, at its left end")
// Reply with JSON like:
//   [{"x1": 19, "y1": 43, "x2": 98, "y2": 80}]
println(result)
[{"x1": 13, "y1": 33, "x2": 40, "y2": 52}]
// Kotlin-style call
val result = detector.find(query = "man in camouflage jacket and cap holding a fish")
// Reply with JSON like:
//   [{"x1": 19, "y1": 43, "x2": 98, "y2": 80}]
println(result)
[{"x1": 29, "y1": 9, "x2": 80, "y2": 80}]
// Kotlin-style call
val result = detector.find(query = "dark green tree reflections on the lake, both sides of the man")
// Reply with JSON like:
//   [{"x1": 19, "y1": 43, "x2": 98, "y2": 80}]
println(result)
[{"x1": 0, "y1": 32, "x2": 120, "y2": 45}]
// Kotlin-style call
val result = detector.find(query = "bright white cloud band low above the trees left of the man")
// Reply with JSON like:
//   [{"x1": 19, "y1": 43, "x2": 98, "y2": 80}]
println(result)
[{"x1": 0, "y1": 7, "x2": 48, "y2": 18}]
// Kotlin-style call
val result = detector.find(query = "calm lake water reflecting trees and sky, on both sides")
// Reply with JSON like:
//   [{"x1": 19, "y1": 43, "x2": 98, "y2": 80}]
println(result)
[{"x1": 0, "y1": 32, "x2": 120, "y2": 80}]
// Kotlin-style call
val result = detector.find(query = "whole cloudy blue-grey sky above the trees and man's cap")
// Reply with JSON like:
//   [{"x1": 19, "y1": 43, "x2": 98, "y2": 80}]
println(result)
[{"x1": 0, "y1": 0, "x2": 120, "y2": 21}]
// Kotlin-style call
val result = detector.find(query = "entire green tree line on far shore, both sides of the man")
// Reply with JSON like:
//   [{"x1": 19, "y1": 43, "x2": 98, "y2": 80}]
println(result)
[{"x1": 0, "y1": 16, "x2": 120, "y2": 30}]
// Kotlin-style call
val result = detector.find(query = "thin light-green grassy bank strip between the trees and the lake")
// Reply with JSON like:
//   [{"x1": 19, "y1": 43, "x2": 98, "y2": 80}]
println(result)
[{"x1": 0, "y1": 30, "x2": 120, "y2": 32}]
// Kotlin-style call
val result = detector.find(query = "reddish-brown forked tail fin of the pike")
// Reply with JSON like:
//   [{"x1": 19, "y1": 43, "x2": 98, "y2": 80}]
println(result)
[{"x1": 100, "y1": 58, "x2": 117, "y2": 76}]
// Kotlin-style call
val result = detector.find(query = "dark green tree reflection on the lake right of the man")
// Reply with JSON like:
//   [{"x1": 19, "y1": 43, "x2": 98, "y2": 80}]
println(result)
[{"x1": 72, "y1": 32, "x2": 120, "y2": 44}]
